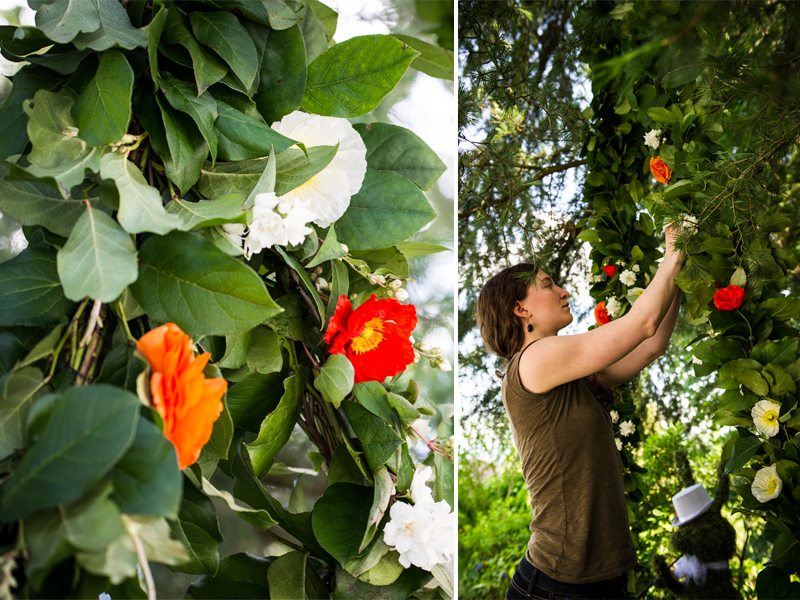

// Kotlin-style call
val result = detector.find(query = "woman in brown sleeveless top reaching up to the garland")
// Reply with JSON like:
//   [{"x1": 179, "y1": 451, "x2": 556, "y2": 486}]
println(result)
[{"x1": 477, "y1": 226, "x2": 682, "y2": 599}]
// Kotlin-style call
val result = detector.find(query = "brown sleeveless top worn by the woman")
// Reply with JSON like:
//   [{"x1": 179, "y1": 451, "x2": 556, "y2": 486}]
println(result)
[{"x1": 502, "y1": 346, "x2": 636, "y2": 583}]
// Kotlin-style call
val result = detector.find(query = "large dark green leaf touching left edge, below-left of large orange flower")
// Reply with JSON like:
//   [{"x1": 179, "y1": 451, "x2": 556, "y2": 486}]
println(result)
[{"x1": 0, "y1": 385, "x2": 140, "y2": 522}]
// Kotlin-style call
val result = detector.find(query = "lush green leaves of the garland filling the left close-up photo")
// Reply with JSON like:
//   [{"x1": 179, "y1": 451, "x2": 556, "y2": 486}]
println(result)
[{"x1": 0, "y1": 0, "x2": 453, "y2": 598}]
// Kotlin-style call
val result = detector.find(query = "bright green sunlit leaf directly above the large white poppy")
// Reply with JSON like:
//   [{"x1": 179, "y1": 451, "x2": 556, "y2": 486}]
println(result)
[{"x1": 302, "y1": 35, "x2": 419, "y2": 118}]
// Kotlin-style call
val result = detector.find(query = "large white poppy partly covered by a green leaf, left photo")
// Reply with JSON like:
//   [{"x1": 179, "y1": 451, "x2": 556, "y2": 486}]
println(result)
[{"x1": 272, "y1": 110, "x2": 367, "y2": 227}]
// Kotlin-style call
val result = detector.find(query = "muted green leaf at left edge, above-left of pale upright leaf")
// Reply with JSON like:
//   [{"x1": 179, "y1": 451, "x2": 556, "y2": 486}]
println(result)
[{"x1": 0, "y1": 162, "x2": 84, "y2": 237}]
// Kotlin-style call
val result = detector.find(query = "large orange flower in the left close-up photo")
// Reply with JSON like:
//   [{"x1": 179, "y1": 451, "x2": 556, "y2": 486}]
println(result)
[{"x1": 136, "y1": 323, "x2": 228, "y2": 469}]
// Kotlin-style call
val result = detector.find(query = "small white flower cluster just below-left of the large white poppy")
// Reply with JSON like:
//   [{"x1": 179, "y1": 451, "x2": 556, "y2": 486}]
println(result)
[{"x1": 222, "y1": 192, "x2": 314, "y2": 258}]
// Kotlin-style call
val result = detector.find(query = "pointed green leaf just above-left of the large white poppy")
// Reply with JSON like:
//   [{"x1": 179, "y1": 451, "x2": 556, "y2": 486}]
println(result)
[{"x1": 214, "y1": 99, "x2": 295, "y2": 161}]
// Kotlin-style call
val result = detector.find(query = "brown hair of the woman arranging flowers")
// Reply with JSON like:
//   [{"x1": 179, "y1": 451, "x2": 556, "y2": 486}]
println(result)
[{"x1": 475, "y1": 263, "x2": 539, "y2": 360}]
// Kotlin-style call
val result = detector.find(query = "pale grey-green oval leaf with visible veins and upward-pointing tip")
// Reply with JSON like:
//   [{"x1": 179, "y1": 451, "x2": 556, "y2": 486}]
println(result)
[{"x1": 58, "y1": 202, "x2": 138, "y2": 302}]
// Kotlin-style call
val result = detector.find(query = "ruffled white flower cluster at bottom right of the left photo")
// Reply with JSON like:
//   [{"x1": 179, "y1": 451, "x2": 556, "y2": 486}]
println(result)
[{"x1": 383, "y1": 466, "x2": 455, "y2": 571}]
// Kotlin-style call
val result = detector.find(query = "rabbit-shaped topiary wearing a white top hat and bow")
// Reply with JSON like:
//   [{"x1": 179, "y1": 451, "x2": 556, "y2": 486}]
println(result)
[{"x1": 652, "y1": 451, "x2": 741, "y2": 599}]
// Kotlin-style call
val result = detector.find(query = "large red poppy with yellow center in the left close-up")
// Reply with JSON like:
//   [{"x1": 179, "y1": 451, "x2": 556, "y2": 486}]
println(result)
[{"x1": 324, "y1": 294, "x2": 417, "y2": 383}]
